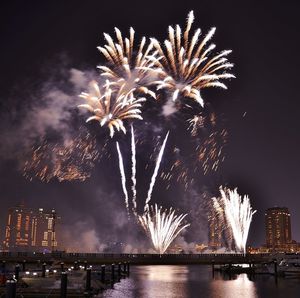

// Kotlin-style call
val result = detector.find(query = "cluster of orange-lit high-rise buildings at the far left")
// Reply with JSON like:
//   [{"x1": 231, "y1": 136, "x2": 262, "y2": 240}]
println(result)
[{"x1": 3, "y1": 204, "x2": 59, "y2": 251}]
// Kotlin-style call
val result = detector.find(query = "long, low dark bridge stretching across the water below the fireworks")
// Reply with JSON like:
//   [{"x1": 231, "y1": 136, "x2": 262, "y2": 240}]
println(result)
[{"x1": 0, "y1": 252, "x2": 274, "y2": 265}]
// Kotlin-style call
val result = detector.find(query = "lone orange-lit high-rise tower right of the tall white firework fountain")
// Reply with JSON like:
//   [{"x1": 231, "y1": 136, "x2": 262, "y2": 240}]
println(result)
[{"x1": 265, "y1": 207, "x2": 292, "y2": 251}]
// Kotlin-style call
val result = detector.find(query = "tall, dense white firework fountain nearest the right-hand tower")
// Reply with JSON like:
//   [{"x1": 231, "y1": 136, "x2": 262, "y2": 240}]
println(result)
[{"x1": 213, "y1": 187, "x2": 256, "y2": 253}]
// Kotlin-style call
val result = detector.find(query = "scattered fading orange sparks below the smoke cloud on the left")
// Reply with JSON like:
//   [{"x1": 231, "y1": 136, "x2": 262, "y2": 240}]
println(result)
[{"x1": 23, "y1": 133, "x2": 100, "y2": 182}]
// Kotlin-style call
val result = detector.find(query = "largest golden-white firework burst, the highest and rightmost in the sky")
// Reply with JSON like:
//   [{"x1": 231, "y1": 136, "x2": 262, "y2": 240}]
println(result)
[{"x1": 148, "y1": 11, "x2": 235, "y2": 107}]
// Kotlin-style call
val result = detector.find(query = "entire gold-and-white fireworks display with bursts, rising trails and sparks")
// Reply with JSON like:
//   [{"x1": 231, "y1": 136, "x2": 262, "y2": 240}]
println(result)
[{"x1": 24, "y1": 11, "x2": 244, "y2": 254}]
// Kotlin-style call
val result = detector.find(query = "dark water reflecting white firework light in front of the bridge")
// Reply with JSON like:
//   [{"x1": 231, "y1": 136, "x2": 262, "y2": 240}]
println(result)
[{"x1": 99, "y1": 265, "x2": 300, "y2": 298}]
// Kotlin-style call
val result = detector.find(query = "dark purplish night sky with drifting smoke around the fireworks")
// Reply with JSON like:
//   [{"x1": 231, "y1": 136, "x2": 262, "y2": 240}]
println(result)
[{"x1": 0, "y1": 1, "x2": 300, "y2": 250}]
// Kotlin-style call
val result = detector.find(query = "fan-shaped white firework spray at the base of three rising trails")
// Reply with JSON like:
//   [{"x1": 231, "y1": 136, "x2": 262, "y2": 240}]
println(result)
[{"x1": 138, "y1": 204, "x2": 190, "y2": 254}]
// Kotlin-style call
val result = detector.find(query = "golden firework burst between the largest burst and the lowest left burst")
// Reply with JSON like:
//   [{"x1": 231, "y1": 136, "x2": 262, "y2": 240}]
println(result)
[{"x1": 98, "y1": 28, "x2": 157, "y2": 98}]
